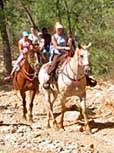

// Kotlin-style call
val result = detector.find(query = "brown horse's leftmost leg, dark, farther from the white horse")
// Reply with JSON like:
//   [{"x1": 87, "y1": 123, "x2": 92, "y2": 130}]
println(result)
[{"x1": 20, "y1": 90, "x2": 27, "y2": 119}]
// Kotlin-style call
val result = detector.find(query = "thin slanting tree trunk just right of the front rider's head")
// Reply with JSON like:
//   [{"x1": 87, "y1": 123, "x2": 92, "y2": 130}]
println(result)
[{"x1": 64, "y1": 0, "x2": 72, "y2": 34}]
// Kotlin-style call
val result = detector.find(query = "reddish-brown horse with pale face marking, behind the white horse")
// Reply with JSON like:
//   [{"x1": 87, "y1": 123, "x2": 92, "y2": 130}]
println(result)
[{"x1": 13, "y1": 51, "x2": 41, "y2": 122}]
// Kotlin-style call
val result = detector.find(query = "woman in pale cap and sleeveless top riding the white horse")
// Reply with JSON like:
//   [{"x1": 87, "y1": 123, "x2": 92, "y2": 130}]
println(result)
[{"x1": 44, "y1": 22, "x2": 70, "y2": 88}]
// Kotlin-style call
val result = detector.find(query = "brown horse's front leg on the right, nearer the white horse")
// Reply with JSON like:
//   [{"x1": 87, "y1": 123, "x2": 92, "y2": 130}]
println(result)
[{"x1": 28, "y1": 90, "x2": 36, "y2": 122}]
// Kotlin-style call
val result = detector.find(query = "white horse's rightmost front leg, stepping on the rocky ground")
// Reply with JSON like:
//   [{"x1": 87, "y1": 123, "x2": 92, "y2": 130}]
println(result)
[{"x1": 80, "y1": 96, "x2": 90, "y2": 132}]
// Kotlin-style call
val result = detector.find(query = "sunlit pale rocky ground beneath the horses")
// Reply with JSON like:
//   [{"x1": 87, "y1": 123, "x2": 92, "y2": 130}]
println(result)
[{"x1": 0, "y1": 72, "x2": 114, "y2": 153}]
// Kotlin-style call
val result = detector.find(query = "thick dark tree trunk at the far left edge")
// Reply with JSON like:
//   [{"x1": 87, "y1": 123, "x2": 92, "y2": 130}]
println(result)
[{"x1": 0, "y1": 0, "x2": 12, "y2": 73}]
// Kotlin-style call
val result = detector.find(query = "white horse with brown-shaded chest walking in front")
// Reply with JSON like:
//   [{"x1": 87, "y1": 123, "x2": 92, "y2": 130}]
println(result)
[{"x1": 39, "y1": 44, "x2": 91, "y2": 131}]
